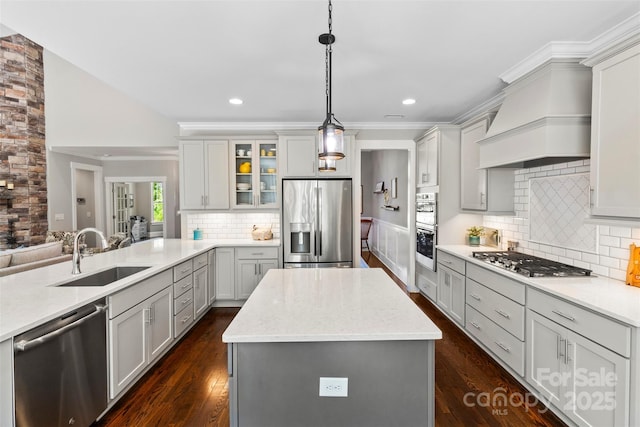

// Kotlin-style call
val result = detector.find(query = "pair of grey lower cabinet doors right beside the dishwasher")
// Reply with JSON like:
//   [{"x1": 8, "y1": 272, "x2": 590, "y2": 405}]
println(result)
[{"x1": 109, "y1": 286, "x2": 173, "y2": 399}]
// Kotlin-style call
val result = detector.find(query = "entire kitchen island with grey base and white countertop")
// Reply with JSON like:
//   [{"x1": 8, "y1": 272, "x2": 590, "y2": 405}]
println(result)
[{"x1": 222, "y1": 269, "x2": 442, "y2": 426}]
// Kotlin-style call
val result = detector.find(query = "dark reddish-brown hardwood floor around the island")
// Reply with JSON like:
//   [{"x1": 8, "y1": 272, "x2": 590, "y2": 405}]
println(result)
[{"x1": 94, "y1": 252, "x2": 564, "y2": 427}]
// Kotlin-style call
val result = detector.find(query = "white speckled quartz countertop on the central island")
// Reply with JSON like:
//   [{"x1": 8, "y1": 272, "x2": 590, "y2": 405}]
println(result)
[{"x1": 222, "y1": 268, "x2": 442, "y2": 343}]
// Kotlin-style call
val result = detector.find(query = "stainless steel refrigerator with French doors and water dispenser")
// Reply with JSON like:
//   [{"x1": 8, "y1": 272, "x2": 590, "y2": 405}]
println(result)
[{"x1": 282, "y1": 179, "x2": 353, "y2": 268}]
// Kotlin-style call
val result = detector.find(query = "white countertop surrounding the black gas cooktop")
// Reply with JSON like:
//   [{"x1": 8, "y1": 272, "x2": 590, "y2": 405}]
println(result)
[{"x1": 437, "y1": 245, "x2": 640, "y2": 327}]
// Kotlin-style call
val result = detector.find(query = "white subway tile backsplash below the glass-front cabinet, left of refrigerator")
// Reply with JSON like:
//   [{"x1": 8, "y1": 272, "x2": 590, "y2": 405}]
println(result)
[{"x1": 185, "y1": 212, "x2": 280, "y2": 239}]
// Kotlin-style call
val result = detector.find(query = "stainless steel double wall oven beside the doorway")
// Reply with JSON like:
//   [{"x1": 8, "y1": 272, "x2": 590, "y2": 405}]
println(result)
[{"x1": 416, "y1": 193, "x2": 438, "y2": 271}]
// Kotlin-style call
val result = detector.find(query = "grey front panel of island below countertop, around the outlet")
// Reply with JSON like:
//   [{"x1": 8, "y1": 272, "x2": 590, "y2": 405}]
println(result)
[{"x1": 229, "y1": 341, "x2": 435, "y2": 427}]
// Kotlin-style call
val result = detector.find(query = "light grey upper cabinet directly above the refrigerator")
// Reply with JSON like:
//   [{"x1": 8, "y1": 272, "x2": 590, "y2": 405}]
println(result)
[{"x1": 279, "y1": 133, "x2": 354, "y2": 178}]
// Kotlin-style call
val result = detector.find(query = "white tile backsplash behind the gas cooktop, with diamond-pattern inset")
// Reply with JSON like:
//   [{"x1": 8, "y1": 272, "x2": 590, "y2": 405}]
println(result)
[{"x1": 483, "y1": 159, "x2": 640, "y2": 280}]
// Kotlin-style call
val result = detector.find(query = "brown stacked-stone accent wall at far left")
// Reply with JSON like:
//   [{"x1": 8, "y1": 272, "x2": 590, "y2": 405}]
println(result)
[{"x1": 0, "y1": 34, "x2": 48, "y2": 249}]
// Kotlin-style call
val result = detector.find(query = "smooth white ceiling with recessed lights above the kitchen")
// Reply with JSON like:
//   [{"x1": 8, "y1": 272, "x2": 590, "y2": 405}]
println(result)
[{"x1": 0, "y1": 0, "x2": 640, "y2": 127}]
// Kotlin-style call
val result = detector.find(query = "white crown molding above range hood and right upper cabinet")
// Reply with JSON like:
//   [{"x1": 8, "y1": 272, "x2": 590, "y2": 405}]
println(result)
[{"x1": 500, "y1": 12, "x2": 640, "y2": 84}]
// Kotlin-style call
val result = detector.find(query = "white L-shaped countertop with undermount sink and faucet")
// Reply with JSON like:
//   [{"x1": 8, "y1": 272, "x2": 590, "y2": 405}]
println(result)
[{"x1": 0, "y1": 239, "x2": 280, "y2": 341}]
